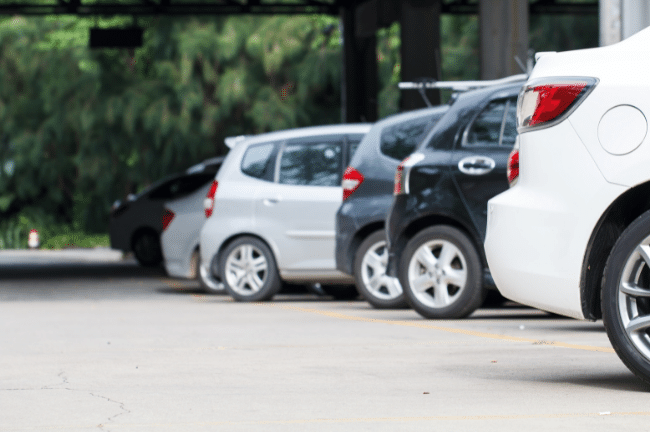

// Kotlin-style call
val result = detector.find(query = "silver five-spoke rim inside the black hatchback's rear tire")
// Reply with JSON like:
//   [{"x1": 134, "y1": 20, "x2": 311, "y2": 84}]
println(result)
[{"x1": 408, "y1": 239, "x2": 467, "y2": 309}]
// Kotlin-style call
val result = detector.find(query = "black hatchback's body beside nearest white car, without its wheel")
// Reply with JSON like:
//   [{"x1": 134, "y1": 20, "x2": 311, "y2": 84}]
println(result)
[{"x1": 386, "y1": 82, "x2": 523, "y2": 276}]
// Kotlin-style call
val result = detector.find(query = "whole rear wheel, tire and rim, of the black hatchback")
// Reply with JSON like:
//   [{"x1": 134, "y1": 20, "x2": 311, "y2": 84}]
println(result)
[{"x1": 398, "y1": 225, "x2": 487, "y2": 319}]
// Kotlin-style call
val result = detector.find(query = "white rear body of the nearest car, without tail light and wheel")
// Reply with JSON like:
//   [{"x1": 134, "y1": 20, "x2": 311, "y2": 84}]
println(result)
[{"x1": 485, "y1": 29, "x2": 650, "y2": 319}]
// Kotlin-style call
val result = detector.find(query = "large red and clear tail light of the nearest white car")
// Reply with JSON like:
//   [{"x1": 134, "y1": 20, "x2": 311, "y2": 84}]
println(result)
[{"x1": 517, "y1": 78, "x2": 598, "y2": 132}]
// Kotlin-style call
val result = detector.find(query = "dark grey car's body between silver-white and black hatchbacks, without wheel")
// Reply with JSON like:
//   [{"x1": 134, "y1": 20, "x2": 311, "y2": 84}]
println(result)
[{"x1": 336, "y1": 106, "x2": 449, "y2": 274}]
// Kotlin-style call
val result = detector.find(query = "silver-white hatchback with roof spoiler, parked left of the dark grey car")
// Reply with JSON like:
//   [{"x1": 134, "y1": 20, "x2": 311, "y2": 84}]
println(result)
[{"x1": 200, "y1": 124, "x2": 370, "y2": 301}]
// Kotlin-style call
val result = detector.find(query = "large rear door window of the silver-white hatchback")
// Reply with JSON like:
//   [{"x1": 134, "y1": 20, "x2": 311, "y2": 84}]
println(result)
[{"x1": 278, "y1": 139, "x2": 343, "y2": 186}]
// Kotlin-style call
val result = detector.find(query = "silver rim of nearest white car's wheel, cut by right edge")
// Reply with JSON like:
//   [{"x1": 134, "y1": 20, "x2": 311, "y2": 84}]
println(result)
[{"x1": 618, "y1": 237, "x2": 650, "y2": 360}]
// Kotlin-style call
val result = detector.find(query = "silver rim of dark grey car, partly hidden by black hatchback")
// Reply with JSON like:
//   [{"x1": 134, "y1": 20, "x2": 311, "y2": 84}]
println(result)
[{"x1": 361, "y1": 240, "x2": 402, "y2": 300}]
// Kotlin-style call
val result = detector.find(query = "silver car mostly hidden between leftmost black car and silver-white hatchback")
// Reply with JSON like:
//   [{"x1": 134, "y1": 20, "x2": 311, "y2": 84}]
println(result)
[{"x1": 160, "y1": 157, "x2": 224, "y2": 291}]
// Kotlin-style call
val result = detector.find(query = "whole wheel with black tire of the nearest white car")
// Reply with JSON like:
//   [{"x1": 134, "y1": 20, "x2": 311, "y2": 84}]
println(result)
[{"x1": 601, "y1": 211, "x2": 650, "y2": 386}]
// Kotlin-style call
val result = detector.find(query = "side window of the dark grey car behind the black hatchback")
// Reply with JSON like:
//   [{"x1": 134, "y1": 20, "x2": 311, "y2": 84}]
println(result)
[{"x1": 379, "y1": 117, "x2": 433, "y2": 160}]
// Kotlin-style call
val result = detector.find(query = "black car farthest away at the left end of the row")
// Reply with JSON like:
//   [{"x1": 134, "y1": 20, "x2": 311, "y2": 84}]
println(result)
[{"x1": 109, "y1": 157, "x2": 224, "y2": 266}]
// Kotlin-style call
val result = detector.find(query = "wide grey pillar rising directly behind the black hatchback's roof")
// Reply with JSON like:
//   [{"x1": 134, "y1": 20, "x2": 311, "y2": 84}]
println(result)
[{"x1": 479, "y1": 0, "x2": 528, "y2": 79}]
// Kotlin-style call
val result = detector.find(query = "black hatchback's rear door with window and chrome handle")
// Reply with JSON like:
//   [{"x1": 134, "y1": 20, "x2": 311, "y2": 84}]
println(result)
[{"x1": 451, "y1": 96, "x2": 517, "y2": 238}]
